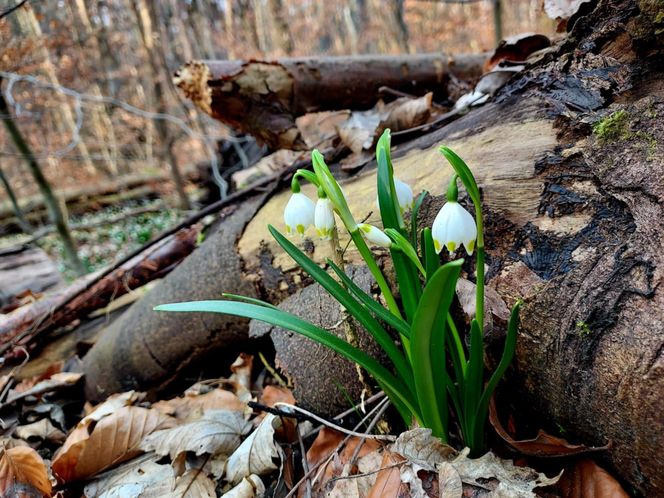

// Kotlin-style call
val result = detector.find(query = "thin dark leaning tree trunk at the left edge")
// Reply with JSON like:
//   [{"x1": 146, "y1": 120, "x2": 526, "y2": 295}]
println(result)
[{"x1": 0, "y1": 80, "x2": 85, "y2": 275}]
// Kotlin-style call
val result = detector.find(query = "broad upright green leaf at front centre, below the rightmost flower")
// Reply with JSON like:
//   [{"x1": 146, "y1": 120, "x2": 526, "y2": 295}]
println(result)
[{"x1": 411, "y1": 259, "x2": 463, "y2": 439}]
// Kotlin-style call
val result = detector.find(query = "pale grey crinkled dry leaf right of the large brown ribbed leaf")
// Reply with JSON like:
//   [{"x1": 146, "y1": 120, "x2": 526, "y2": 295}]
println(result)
[{"x1": 140, "y1": 410, "x2": 251, "y2": 460}]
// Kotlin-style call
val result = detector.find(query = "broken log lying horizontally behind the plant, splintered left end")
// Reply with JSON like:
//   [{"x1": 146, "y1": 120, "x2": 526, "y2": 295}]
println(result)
[{"x1": 174, "y1": 54, "x2": 486, "y2": 149}]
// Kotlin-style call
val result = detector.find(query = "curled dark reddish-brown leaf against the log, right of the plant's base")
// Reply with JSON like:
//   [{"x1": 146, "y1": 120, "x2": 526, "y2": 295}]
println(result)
[{"x1": 489, "y1": 397, "x2": 609, "y2": 458}]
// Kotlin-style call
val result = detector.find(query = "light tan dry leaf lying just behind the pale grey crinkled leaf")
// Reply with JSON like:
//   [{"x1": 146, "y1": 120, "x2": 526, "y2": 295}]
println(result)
[{"x1": 152, "y1": 389, "x2": 249, "y2": 420}]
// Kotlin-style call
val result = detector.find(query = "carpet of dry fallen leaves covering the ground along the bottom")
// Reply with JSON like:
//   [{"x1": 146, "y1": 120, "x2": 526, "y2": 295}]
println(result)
[{"x1": 0, "y1": 355, "x2": 627, "y2": 498}]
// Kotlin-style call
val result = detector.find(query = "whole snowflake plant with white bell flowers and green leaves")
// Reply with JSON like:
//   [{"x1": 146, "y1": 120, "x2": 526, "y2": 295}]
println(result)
[{"x1": 155, "y1": 130, "x2": 520, "y2": 455}]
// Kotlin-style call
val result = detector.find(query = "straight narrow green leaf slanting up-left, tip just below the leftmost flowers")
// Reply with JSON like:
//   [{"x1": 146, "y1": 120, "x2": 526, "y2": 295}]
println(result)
[{"x1": 268, "y1": 225, "x2": 413, "y2": 389}]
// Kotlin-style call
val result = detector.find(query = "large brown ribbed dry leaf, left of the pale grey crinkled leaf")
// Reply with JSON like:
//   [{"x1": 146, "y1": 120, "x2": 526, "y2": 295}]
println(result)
[{"x1": 52, "y1": 406, "x2": 173, "y2": 482}]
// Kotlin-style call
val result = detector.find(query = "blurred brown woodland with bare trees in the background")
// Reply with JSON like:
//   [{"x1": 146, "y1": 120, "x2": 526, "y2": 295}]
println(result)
[{"x1": 0, "y1": 0, "x2": 555, "y2": 276}]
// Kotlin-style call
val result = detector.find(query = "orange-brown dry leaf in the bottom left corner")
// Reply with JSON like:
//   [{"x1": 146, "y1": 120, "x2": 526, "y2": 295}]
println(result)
[{"x1": 0, "y1": 446, "x2": 51, "y2": 497}]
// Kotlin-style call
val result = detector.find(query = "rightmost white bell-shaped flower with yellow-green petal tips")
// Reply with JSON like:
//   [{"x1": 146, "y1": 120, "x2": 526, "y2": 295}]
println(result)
[{"x1": 431, "y1": 201, "x2": 477, "y2": 256}]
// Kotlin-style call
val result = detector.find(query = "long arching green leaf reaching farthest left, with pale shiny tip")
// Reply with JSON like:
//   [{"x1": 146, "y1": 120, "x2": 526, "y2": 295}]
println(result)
[{"x1": 154, "y1": 301, "x2": 419, "y2": 415}]
